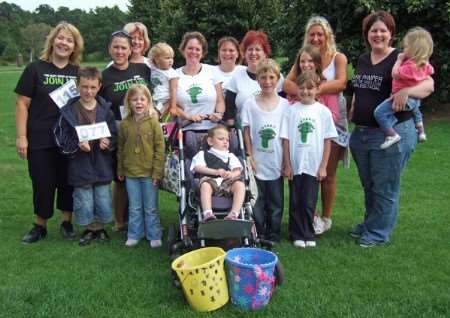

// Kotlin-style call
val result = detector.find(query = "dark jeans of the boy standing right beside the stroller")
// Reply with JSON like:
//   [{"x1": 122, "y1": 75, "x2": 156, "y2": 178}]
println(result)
[{"x1": 253, "y1": 177, "x2": 284, "y2": 241}]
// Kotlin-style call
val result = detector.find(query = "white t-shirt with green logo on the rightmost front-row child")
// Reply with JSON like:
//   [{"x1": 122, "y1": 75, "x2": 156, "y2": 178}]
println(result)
[{"x1": 280, "y1": 102, "x2": 337, "y2": 176}]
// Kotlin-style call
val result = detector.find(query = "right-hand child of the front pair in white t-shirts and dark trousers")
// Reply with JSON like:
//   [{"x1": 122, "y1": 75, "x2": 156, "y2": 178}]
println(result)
[{"x1": 281, "y1": 72, "x2": 337, "y2": 248}]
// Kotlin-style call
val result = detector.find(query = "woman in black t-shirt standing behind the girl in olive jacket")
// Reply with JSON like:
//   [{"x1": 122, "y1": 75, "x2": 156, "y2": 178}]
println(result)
[{"x1": 99, "y1": 31, "x2": 150, "y2": 231}]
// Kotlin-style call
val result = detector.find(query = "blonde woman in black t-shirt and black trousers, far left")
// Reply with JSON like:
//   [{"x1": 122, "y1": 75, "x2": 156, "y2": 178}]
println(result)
[{"x1": 15, "y1": 22, "x2": 84, "y2": 243}]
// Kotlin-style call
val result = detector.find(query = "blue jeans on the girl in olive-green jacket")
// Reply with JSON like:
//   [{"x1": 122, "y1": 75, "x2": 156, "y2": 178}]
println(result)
[{"x1": 125, "y1": 177, "x2": 161, "y2": 240}]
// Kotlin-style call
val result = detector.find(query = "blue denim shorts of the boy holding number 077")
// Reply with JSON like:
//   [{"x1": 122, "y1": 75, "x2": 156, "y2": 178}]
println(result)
[{"x1": 73, "y1": 184, "x2": 112, "y2": 225}]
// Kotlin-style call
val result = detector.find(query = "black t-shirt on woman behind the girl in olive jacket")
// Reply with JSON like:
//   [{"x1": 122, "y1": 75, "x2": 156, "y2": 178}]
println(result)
[{"x1": 99, "y1": 63, "x2": 150, "y2": 120}]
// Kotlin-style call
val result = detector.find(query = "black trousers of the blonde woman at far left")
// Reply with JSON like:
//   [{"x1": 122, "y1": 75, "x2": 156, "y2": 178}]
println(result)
[{"x1": 28, "y1": 148, "x2": 73, "y2": 220}]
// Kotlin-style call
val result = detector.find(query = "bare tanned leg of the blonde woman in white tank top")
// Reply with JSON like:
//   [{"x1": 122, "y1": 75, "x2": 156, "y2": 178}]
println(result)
[{"x1": 321, "y1": 142, "x2": 344, "y2": 218}]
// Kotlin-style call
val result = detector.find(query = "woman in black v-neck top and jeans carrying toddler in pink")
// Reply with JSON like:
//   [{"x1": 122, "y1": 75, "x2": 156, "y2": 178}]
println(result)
[{"x1": 350, "y1": 11, "x2": 434, "y2": 247}]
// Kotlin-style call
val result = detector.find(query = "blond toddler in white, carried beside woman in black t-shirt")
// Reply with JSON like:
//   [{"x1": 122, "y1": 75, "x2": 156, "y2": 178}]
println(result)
[{"x1": 149, "y1": 42, "x2": 179, "y2": 116}]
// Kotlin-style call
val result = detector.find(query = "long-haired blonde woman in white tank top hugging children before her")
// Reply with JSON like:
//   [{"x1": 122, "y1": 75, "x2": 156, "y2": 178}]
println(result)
[{"x1": 284, "y1": 16, "x2": 348, "y2": 234}]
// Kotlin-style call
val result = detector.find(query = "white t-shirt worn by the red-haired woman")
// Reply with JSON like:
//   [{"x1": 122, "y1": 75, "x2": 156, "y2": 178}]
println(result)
[{"x1": 225, "y1": 67, "x2": 284, "y2": 120}]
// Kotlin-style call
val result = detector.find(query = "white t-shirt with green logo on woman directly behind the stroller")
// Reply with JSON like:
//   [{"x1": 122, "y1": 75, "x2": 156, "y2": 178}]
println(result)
[{"x1": 176, "y1": 64, "x2": 220, "y2": 130}]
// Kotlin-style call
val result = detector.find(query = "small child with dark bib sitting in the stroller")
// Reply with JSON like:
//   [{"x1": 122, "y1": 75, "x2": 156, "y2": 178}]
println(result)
[{"x1": 190, "y1": 125, "x2": 245, "y2": 222}]
